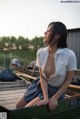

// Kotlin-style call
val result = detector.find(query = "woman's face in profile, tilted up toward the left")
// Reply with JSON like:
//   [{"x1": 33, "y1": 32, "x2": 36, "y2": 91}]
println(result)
[{"x1": 43, "y1": 25, "x2": 53, "y2": 45}]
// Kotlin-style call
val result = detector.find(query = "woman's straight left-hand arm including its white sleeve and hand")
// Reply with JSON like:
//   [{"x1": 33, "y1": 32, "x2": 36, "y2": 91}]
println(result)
[{"x1": 36, "y1": 49, "x2": 48, "y2": 105}]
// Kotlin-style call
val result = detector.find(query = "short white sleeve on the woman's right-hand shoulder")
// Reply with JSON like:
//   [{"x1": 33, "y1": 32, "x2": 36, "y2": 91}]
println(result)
[{"x1": 67, "y1": 52, "x2": 77, "y2": 71}]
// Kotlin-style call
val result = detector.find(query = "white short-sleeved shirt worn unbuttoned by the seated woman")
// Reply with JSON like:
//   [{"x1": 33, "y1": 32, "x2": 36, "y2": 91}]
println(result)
[{"x1": 36, "y1": 47, "x2": 77, "y2": 87}]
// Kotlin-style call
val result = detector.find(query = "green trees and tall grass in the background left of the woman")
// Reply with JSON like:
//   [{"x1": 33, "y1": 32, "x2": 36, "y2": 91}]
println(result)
[{"x1": 0, "y1": 36, "x2": 43, "y2": 67}]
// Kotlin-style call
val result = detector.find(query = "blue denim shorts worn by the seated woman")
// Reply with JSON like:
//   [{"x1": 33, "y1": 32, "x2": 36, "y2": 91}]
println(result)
[{"x1": 24, "y1": 78, "x2": 64, "y2": 102}]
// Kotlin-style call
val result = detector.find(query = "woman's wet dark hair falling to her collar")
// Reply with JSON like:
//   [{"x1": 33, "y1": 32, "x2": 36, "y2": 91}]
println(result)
[{"x1": 48, "y1": 22, "x2": 67, "y2": 48}]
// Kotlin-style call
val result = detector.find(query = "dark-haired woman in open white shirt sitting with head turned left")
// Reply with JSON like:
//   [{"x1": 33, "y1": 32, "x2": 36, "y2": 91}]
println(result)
[{"x1": 16, "y1": 22, "x2": 76, "y2": 110}]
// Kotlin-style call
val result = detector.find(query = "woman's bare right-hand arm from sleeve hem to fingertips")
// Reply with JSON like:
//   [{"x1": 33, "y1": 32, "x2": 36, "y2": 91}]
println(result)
[{"x1": 48, "y1": 71, "x2": 74, "y2": 110}]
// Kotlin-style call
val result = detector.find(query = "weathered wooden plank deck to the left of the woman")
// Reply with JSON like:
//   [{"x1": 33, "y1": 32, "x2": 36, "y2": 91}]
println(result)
[{"x1": 0, "y1": 80, "x2": 29, "y2": 109}]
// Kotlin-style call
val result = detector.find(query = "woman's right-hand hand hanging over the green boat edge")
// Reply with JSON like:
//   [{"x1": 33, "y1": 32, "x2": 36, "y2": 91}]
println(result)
[{"x1": 48, "y1": 96, "x2": 58, "y2": 110}]
